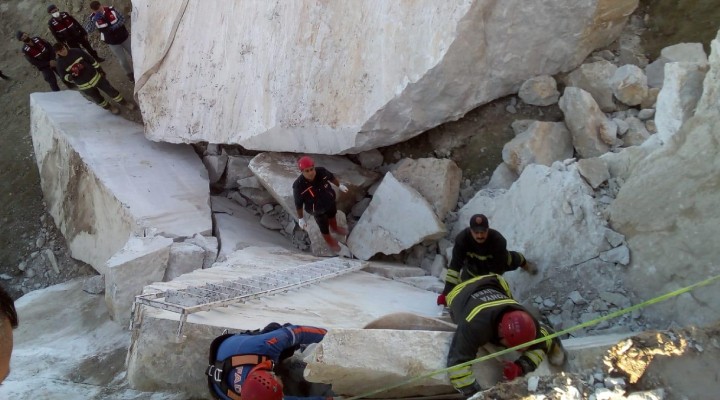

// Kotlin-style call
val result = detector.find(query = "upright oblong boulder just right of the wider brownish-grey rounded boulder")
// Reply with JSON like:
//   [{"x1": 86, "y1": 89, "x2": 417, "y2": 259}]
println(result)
[{"x1": 559, "y1": 87, "x2": 610, "y2": 158}]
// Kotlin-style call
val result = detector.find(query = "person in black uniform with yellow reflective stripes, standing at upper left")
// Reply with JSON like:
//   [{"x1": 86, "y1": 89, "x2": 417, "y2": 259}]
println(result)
[{"x1": 53, "y1": 43, "x2": 137, "y2": 114}]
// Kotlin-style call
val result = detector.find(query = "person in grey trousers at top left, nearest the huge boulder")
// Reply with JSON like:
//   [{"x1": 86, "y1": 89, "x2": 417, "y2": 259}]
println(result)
[{"x1": 88, "y1": 1, "x2": 135, "y2": 83}]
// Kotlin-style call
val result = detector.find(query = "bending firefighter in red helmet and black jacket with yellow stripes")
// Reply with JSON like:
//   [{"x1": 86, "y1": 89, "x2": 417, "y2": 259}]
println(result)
[{"x1": 447, "y1": 274, "x2": 566, "y2": 399}]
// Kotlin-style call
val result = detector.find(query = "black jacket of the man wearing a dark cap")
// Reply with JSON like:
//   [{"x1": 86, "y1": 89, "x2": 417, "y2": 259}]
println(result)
[{"x1": 443, "y1": 228, "x2": 525, "y2": 295}]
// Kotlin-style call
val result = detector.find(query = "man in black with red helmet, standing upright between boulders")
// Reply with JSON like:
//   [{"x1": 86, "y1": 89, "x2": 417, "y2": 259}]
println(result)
[{"x1": 293, "y1": 156, "x2": 348, "y2": 253}]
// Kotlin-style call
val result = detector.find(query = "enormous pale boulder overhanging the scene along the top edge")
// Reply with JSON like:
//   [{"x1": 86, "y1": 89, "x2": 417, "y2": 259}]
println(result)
[{"x1": 132, "y1": 0, "x2": 638, "y2": 154}]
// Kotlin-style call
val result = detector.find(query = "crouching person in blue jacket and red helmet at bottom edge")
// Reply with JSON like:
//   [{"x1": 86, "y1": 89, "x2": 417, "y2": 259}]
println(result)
[{"x1": 205, "y1": 323, "x2": 333, "y2": 400}]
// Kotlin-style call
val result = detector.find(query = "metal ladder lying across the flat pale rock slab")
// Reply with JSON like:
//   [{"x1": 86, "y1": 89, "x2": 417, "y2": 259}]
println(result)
[{"x1": 130, "y1": 257, "x2": 367, "y2": 340}]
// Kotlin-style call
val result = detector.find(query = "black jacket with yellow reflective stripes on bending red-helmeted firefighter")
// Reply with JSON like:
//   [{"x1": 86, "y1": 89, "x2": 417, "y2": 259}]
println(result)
[{"x1": 447, "y1": 274, "x2": 553, "y2": 390}]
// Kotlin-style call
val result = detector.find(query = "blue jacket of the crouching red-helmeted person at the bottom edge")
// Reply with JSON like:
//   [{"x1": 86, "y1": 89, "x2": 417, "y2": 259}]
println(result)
[{"x1": 211, "y1": 324, "x2": 327, "y2": 400}]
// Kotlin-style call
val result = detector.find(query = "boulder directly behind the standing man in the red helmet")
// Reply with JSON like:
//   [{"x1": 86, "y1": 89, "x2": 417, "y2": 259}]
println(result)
[{"x1": 249, "y1": 152, "x2": 380, "y2": 218}]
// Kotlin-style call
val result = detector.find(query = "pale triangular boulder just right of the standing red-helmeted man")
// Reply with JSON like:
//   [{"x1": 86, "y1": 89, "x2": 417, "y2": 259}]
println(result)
[{"x1": 348, "y1": 173, "x2": 444, "y2": 260}]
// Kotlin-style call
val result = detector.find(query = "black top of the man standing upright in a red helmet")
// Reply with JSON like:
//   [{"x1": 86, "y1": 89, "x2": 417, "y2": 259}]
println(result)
[{"x1": 293, "y1": 167, "x2": 336, "y2": 215}]
